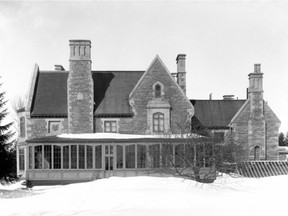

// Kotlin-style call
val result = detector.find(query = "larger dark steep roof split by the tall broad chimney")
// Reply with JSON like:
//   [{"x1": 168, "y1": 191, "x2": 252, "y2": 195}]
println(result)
[{"x1": 31, "y1": 71, "x2": 144, "y2": 117}]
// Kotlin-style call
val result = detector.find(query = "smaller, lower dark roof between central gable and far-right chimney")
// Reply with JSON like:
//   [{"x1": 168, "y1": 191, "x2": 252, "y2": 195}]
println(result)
[{"x1": 190, "y1": 100, "x2": 246, "y2": 129}]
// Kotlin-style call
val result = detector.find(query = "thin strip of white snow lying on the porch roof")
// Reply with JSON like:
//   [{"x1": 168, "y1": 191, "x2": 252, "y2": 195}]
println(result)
[{"x1": 57, "y1": 133, "x2": 201, "y2": 139}]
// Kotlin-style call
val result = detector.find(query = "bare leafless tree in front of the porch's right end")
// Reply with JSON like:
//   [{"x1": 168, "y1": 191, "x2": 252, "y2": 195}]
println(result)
[{"x1": 149, "y1": 131, "x2": 239, "y2": 182}]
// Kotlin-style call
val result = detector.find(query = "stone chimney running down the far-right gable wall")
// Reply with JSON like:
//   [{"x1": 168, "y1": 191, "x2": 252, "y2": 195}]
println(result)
[{"x1": 247, "y1": 64, "x2": 267, "y2": 160}]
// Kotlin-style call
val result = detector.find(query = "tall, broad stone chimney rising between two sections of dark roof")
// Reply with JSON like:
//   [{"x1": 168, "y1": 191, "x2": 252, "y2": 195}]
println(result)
[{"x1": 67, "y1": 40, "x2": 94, "y2": 133}]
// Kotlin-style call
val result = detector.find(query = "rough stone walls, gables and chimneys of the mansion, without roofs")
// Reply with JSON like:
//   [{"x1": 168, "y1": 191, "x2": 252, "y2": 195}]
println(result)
[{"x1": 18, "y1": 40, "x2": 280, "y2": 167}]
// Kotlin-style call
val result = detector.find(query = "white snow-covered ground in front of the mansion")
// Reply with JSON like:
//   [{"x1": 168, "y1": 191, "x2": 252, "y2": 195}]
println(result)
[{"x1": 0, "y1": 176, "x2": 288, "y2": 216}]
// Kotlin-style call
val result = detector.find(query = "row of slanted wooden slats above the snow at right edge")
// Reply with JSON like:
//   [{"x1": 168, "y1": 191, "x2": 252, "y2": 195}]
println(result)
[{"x1": 237, "y1": 161, "x2": 288, "y2": 178}]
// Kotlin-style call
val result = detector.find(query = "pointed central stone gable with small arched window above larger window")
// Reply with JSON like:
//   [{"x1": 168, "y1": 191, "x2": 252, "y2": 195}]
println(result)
[{"x1": 129, "y1": 56, "x2": 194, "y2": 134}]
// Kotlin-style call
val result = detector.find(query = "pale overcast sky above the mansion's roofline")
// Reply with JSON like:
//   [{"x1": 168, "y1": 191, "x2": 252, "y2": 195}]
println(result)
[{"x1": 0, "y1": 1, "x2": 288, "y2": 132}]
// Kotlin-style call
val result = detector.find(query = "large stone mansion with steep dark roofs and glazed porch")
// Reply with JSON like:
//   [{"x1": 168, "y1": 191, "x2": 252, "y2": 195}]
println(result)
[{"x1": 17, "y1": 40, "x2": 280, "y2": 184}]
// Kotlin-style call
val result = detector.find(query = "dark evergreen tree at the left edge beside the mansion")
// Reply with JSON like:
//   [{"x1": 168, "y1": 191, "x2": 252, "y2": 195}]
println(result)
[{"x1": 0, "y1": 80, "x2": 16, "y2": 183}]
